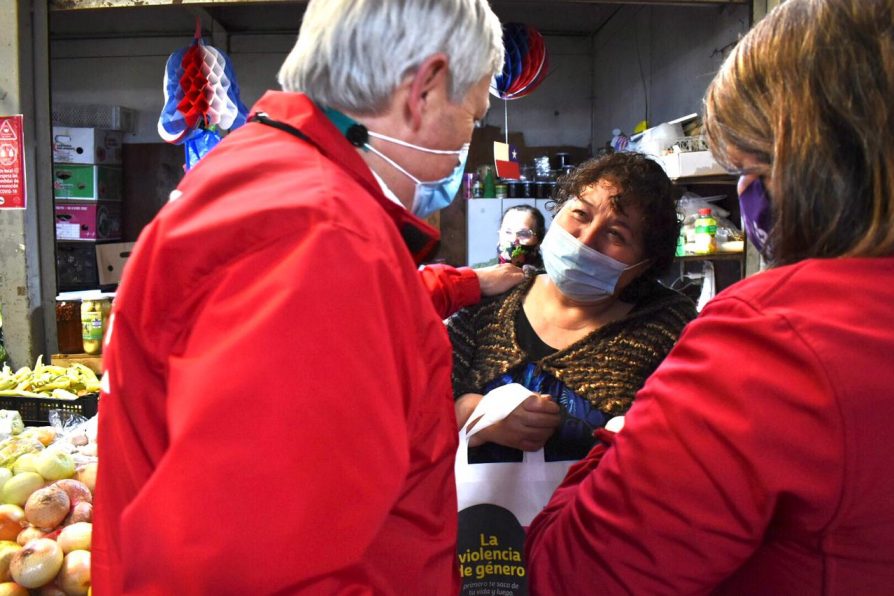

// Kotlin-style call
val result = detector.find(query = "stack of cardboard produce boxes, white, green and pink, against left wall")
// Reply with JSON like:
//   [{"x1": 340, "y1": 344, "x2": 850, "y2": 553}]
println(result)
[{"x1": 53, "y1": 126, "x2": 124, "y2": 291}]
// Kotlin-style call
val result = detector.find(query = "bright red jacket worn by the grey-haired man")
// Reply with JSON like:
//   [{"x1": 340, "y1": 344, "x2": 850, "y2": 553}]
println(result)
[{"x1": 93, "y1": 93, "x2": 459, "y2": 596}]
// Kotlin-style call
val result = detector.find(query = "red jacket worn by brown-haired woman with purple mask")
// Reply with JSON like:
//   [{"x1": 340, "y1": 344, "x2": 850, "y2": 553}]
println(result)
[{"x1": 527, "y1": 258, "x2": 894, "y2": 596}]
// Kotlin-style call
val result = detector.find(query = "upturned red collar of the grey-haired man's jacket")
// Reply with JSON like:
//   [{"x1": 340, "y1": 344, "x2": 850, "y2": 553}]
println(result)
[{"x1": 250, "y1": 91, "x2": 440, "y2": 265}]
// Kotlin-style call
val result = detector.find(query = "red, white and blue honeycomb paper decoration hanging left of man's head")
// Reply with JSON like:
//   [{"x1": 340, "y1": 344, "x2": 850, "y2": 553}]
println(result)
[{"x1": 158, "y1": 19, "x2": 248, "y2": 170}]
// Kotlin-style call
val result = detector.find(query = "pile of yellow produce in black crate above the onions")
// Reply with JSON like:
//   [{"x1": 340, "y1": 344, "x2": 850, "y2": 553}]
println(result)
[{"x1": 0, "y1": 355, "x2": 99, "y2": 399}]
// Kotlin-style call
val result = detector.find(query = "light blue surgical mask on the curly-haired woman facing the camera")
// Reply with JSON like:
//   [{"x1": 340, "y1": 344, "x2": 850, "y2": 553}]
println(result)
[{"x1": 540, "y1": 223, "x2": 639, "y2": 302}]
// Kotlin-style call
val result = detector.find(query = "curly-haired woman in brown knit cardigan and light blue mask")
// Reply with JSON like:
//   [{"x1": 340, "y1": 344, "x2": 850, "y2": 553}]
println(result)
[{"x1": 447, "y1": 153, "x2": 696, "y2": 463}]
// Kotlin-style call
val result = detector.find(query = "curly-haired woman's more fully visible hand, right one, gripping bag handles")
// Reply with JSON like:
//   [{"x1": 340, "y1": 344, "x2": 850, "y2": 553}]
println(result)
[{"x1": 469, "y1": 393, "x2": 562, "y2": 451}]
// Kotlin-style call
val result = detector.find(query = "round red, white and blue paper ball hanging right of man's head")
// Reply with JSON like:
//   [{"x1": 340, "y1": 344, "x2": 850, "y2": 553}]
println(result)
[{"x1": 490, "y1": 23, "x2": 549, "y2": 100}]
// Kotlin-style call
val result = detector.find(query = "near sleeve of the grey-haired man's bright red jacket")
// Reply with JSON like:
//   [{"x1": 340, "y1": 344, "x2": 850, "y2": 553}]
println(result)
[{"x1": 121, "y1": 224, "x2": 420, "y2": 594}]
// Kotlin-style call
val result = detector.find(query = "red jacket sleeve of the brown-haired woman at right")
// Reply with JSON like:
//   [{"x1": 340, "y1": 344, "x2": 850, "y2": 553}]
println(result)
[{"x1": 526, "y1": 298, "x2": 843, "y2": 594}]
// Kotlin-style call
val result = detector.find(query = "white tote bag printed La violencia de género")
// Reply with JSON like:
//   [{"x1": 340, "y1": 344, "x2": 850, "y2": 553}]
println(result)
[{"x1": 455, "y1": 383, "x2": 575, "y2": 595}]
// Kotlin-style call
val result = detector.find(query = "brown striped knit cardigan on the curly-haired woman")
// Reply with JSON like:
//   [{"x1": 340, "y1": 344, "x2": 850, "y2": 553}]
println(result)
[{"x1": 447, "y1": 279, "x2": 696, "y2": 416}]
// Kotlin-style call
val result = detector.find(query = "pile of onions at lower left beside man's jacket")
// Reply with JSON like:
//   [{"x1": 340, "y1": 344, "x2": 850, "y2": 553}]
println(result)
[{"x1": 0, "y1": 414, "x2": 97, "y2": 596}]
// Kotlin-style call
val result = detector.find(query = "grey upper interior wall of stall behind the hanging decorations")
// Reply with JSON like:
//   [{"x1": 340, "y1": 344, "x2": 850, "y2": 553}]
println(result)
[{"x1": 51, "y1": 5, "x2": 748, "y2": 147}]
